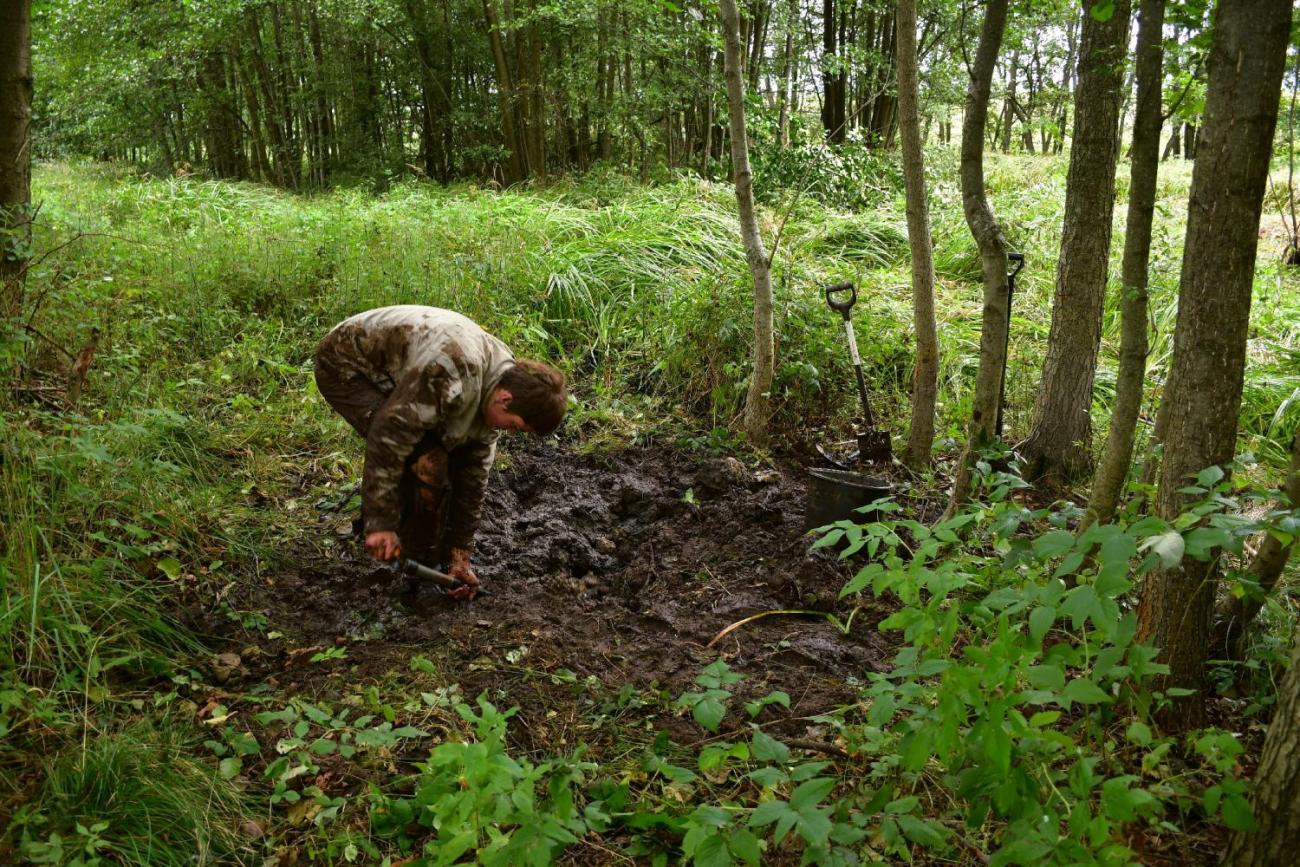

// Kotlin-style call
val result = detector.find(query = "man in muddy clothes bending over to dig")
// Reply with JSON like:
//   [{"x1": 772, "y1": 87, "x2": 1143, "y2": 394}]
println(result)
[{"x1": 316, "y1": 304, "x2": 568, "y2": 598}]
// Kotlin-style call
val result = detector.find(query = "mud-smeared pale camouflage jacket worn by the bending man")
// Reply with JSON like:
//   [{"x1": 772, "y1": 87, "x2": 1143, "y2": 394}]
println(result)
[{"x1": 321, "y1": 304, "x2": 514, "y2": 549}]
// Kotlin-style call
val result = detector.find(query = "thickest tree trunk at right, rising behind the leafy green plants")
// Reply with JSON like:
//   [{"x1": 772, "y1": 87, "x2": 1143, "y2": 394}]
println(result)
[{"x1": 1138, "y1": 0, "x2": 1291, "y2": 729}]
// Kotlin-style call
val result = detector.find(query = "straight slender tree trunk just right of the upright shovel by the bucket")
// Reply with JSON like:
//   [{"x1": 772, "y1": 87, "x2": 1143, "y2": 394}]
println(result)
[{"x1": 896, "y1": 0, "x2": 939, "y2": 469}]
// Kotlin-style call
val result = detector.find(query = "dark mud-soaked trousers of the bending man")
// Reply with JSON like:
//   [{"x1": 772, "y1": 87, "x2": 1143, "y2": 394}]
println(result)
[{"x1": 316, "y1": 354, "x2": 451, "y2": 564}]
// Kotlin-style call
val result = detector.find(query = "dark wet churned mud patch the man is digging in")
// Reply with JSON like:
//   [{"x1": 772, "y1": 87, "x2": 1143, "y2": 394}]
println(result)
[{"x1": 246, "y1": 443, "x2": 893, "y2": 734}]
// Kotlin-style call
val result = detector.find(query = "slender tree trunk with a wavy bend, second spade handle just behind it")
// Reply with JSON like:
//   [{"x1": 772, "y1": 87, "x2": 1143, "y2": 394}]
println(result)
[{"x1": 948, "y1": 0, "x2": 1009, "y2": 515}]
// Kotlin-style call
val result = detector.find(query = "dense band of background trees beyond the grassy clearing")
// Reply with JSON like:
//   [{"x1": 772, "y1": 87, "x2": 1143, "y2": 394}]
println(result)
[{"x1": 34, "y1": 0, "x2": 1208, "y2": 190}]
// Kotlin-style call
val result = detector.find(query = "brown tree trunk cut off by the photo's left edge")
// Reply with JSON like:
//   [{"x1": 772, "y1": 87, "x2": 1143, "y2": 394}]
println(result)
[{"x1": 0, "y1": 0, "x2": 31, "y2": 317}]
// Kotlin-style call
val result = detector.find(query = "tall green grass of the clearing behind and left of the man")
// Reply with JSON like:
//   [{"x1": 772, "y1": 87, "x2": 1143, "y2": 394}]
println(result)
[{"x1": 0, "y1": 149, "x2": 1300, "y2": 863}]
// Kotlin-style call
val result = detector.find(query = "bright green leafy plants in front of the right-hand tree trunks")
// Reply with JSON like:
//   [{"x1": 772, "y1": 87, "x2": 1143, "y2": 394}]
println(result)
[{"x1": 818, "y1": 463, "x2": 1275, "y2": 866}]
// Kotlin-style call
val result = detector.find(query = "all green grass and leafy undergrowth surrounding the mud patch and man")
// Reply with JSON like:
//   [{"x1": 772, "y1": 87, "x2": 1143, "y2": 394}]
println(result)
[{"x1": 0, "y1": 153, "x2": 1300, "y2": 864}]
